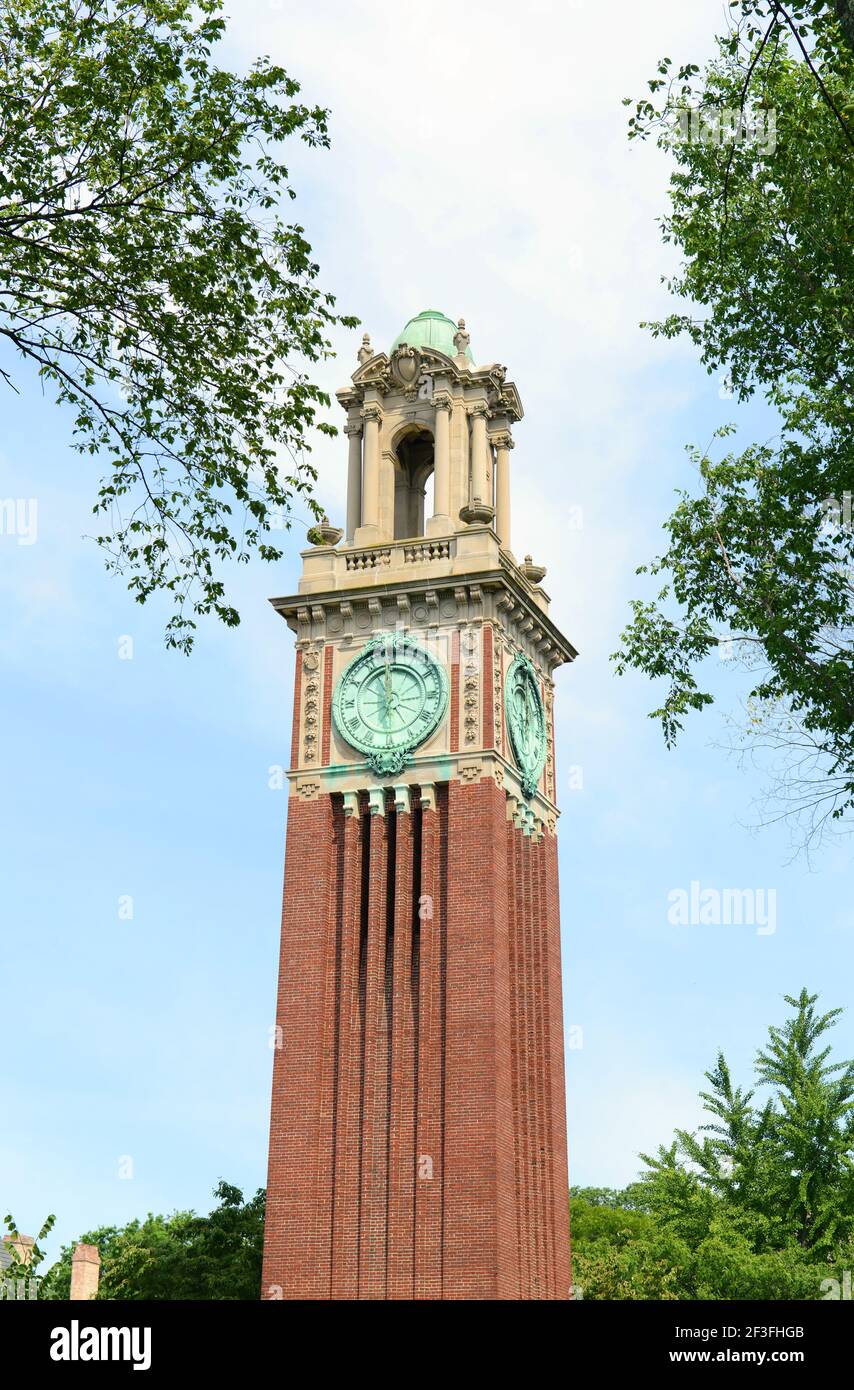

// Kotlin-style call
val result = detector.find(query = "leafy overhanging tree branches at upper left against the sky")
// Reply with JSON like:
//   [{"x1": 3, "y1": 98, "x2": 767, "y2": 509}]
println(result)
[{"x1": 0, "y1": 0, "x2": 356, "y2": 652}]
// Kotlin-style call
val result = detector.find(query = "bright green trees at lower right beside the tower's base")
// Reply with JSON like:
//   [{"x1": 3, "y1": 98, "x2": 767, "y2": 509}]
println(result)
[{"x1": 572, "y1": 990, "x2": 854, "y2": 1300}]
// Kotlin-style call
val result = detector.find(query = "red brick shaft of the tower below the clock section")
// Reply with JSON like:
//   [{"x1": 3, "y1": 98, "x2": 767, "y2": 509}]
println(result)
[{"x1": 263, "y1": 778, "x2": 569, "y2": 1300}]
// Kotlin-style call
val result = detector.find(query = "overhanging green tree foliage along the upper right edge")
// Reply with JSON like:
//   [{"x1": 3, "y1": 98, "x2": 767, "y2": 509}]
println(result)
[{"x1": 615, "y1": 0, "x2": 854, "y2": 842}]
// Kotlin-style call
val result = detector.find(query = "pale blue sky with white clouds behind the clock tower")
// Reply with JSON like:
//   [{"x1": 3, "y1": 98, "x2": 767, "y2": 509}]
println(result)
[{"x1": 0, "y1": 0, "x2": 854, "y2": 1254}]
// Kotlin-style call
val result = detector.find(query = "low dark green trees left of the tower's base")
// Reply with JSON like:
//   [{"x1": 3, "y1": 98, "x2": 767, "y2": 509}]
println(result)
[{"x1": 40, "y1": 1182, "x2": 264, "y2": 1301}]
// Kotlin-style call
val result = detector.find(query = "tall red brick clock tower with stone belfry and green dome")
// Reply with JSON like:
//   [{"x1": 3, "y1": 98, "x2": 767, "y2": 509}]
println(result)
[{"x1": 263, "y1": 311, "x2": 576, "y2": 1300}]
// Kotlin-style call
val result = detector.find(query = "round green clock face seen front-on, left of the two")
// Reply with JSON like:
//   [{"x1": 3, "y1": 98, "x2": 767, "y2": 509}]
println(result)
[{"x1": 332, "y1": 632, "x2": 448, "y2": 777}]
